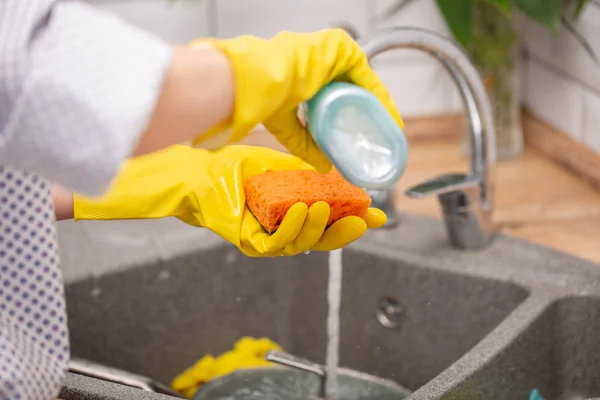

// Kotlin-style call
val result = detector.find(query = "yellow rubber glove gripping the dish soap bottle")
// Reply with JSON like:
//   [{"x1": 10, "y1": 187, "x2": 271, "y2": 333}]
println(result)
[{"x1": 191, "y1": 29, "x2": 404, "y2": 173}]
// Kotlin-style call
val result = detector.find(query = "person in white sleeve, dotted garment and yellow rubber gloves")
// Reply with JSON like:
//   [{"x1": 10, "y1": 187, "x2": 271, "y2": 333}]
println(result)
[{"x1": 0, "y1": 0, "x2": 402, "y2": 400}]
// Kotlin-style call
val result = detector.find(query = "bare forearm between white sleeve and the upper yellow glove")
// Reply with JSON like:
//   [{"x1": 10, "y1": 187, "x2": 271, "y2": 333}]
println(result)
[{"x1": 134, "y1": 45, "x2": 235, "y2": 155}]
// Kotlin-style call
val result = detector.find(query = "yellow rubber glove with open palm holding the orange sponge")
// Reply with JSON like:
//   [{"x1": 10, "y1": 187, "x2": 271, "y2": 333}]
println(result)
[{"x1": 74, "y1": 145, "x2": 386, "y2": 257}]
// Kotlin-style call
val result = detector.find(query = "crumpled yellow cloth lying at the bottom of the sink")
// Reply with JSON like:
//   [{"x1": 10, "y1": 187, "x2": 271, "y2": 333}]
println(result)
[{"x1": 171, "y1": 337, "x2": 283, "y2": 398}]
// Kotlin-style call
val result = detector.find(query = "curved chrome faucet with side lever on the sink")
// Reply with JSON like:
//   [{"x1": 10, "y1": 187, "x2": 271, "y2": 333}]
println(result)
[{"x1": 359, "y1": 28, "x2": 496, "y2": 249}]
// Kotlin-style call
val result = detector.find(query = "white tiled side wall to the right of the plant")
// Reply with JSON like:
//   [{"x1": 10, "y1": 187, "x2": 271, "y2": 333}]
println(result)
[{"x1": 522, "y1": 3, "x2": 600, "y2": 154}]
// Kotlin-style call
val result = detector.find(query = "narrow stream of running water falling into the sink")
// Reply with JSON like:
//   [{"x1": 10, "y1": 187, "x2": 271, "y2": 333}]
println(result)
[{"x1": 325, "y1": 249, "x2": 342, "y2": 400}]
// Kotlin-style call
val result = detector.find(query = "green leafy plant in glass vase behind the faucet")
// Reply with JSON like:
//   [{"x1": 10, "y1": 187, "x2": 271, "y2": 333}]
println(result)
[{"x1": 384, "y1": 0, "x2": 595, "y2": 160}]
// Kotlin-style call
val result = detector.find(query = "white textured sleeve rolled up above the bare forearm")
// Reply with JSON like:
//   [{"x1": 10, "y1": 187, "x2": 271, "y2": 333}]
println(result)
[{"x1": 0, "y1": 0, "x2": 171, "y2": 195}]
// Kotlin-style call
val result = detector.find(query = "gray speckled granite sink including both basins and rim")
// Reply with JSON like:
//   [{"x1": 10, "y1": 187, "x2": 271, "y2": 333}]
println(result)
[{"x1": 59, "y1": 216, "x2": 600, "y2": 400}]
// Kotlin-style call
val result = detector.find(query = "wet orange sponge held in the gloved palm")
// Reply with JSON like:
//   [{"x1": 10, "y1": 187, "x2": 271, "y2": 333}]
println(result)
[{"x1": 244, "y1": 170, "x2": 371, "y2": 233}]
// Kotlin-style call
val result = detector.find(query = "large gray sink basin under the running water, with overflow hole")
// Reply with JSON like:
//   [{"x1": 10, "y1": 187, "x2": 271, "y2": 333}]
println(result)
[{"x1": 61, "y1": 242, "x2": 527, "y2": 389}]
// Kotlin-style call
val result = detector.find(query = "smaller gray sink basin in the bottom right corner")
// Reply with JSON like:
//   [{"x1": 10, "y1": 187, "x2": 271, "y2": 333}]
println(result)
[{"x1": 442, "y1": 296, "x2": 600, "y2": 400}]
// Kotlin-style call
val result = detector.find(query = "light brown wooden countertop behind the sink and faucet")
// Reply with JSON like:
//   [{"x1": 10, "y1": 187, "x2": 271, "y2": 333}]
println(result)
[{"x1": 241, "y1": 117, "x2": 600, "y2": 263}]
